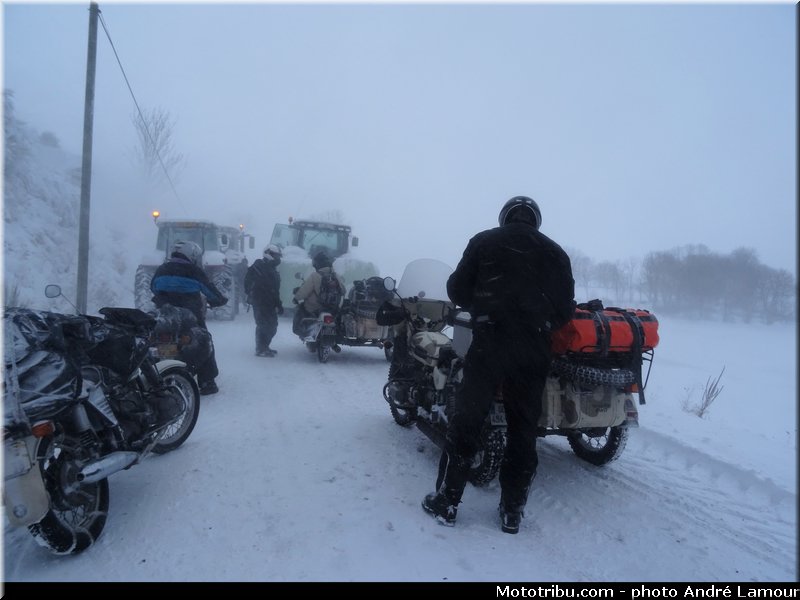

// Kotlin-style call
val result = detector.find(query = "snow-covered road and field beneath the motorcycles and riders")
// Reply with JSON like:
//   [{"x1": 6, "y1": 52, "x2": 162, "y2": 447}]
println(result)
[{"x1": 3, "y1": 307, "x2": 798, "y2": 582}]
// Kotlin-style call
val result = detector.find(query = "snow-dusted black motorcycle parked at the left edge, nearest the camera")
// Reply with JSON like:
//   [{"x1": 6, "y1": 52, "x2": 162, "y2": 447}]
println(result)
[{"x1": 3, "y1": 286, "x2": 200, "y2": 555}]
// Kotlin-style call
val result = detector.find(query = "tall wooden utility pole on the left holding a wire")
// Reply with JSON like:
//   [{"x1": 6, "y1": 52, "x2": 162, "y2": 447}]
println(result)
[{"x1": 77, "y1": 2, "x2": 100, "y2": 313}]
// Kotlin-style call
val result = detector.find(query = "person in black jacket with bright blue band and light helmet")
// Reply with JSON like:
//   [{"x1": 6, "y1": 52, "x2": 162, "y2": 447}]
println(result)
[{"x1": 150, "y1": 241, "x2": 228, "y2": 395}]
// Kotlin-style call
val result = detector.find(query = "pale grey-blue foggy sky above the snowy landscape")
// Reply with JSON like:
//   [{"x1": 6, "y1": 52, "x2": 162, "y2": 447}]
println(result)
[{"x1": 2, "y1": 3, "x2": 797, "y2": 276}]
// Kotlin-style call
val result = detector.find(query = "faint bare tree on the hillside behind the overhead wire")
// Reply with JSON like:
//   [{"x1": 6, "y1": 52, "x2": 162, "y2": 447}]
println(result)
[{"x1": 131, "y1": 108, "x2": 185, "y2": 181}]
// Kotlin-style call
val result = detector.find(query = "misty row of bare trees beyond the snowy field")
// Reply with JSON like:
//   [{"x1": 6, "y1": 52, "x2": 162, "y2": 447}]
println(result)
[{"x1": 567, "y1": 244, "x2": 797, "y2": 323}]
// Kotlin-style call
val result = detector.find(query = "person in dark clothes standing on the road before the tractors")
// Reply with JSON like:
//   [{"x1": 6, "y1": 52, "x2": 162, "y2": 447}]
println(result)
[{"x1": 244, "y1": 244, "x2": 283, "y2": 357}]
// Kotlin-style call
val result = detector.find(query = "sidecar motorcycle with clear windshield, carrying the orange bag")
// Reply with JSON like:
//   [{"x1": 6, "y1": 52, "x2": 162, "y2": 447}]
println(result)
[{"x1": 378, "y1": 259, "x2": 652, "y2": 486}]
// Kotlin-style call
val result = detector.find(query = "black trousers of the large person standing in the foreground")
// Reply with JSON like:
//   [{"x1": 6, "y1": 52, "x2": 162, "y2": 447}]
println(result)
[{"x1": 439, "y1": 322, "x2": 551, "y2": 512}]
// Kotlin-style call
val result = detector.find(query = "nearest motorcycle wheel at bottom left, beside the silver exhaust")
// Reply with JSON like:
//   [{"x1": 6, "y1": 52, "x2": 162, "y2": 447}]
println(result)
[{"x1": 28, "y1": 436, "x2": 109, "y2": 554}]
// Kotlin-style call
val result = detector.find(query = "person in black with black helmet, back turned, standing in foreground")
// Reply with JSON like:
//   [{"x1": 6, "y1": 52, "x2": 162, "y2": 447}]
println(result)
[{"x1": 422, "y1": 196, "x2": 575, "y2": 533}]
